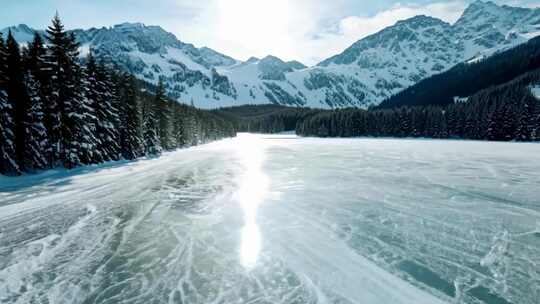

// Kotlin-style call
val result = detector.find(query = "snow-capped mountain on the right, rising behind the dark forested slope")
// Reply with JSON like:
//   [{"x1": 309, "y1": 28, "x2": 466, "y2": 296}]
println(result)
[{"x1": 319, "y1": 1, "x2": 540, "y2": 104}]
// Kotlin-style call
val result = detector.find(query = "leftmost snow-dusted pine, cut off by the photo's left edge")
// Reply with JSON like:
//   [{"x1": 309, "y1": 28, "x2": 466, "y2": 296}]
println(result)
[{"x1": 0, "y1": 34, "x2": 21, "y2": 175}]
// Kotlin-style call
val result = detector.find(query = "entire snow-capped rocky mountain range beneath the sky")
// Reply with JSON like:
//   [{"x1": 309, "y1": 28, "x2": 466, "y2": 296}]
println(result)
[{"x1": 2, "y1": 1, "x2": 540, "y2": 108}]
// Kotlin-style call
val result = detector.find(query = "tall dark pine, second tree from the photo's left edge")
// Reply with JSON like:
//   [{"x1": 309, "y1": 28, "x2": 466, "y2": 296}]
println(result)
[{"x1": 6, "y1": 31, "x2": 28, "y2": 170}]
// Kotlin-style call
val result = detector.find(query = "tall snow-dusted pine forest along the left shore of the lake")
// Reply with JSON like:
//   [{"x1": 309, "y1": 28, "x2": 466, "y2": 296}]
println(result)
[{"x1": 0, "y1": 16, "x2": 235, "y2": 175}]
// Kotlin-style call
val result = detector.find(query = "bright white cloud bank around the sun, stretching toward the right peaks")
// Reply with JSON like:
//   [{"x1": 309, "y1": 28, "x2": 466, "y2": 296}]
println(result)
[{"x1": 141, "y1": 0, "x2": 536, "y2": 65}]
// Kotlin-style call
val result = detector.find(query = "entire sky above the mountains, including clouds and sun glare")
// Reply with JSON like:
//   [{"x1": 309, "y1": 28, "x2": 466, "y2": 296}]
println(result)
[{"x1": 0, "y1": 0, "x2": 540, "y2": 64}]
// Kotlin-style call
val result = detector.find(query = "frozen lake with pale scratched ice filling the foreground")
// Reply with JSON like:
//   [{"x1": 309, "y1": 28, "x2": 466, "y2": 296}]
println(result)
[{"x1": 0, "y1": 134, "x2": 540, "y2": 304}]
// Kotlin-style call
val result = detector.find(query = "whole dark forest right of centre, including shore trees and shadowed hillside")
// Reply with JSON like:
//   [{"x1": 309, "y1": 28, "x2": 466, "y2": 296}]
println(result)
[{"x1": 218, "y1": 37, "x2": 540, "y2": 141}]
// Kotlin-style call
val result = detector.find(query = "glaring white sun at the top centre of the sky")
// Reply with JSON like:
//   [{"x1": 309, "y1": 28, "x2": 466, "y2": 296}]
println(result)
[{"x1": 218, "y1": 0, "x2": 290, "y2": 43}]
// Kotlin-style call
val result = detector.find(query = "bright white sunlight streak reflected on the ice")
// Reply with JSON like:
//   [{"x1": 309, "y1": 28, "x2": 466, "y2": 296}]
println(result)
[{"x1": 235, "y1": 134, "x2": 269, "y2": 269}]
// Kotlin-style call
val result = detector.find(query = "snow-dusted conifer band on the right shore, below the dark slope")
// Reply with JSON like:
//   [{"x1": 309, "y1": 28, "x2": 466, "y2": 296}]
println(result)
[{"x1": 296, "y1": 70, "x2": 540, "y2": 141}]
